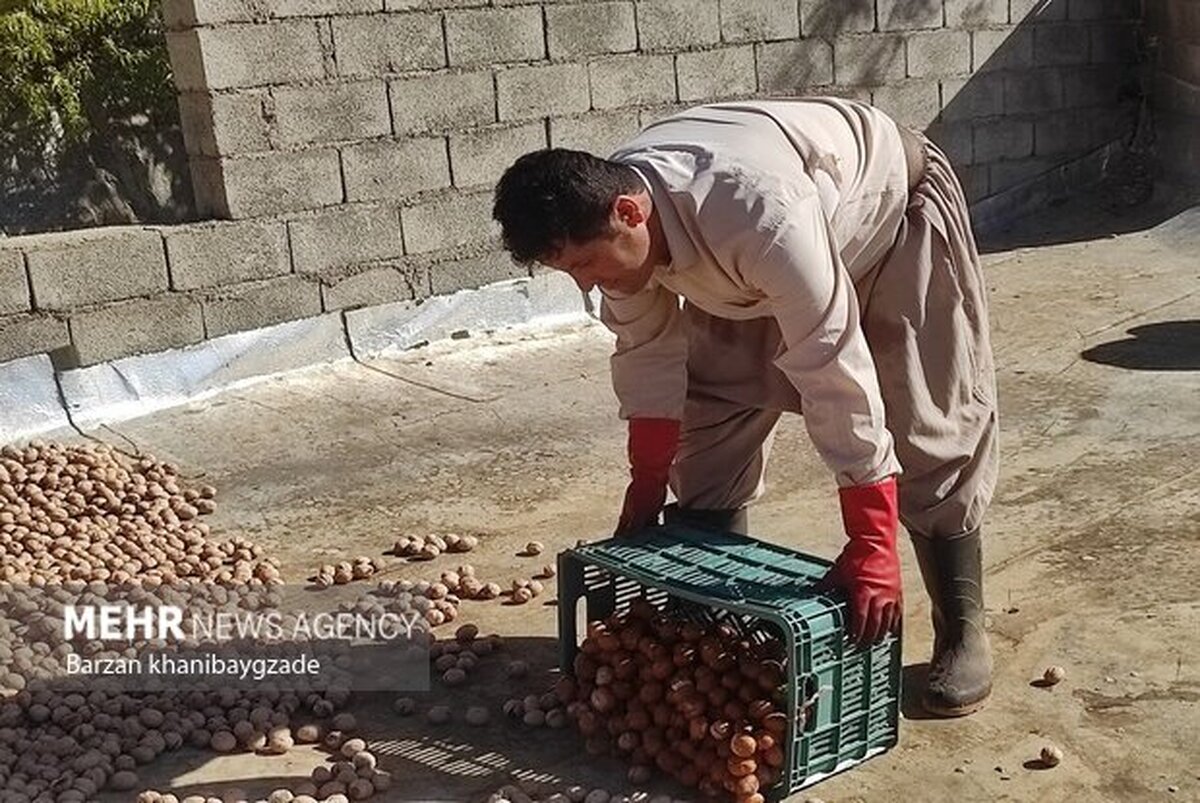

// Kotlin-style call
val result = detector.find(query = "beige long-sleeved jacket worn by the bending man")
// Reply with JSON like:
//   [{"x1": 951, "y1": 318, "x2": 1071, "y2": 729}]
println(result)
[{"x1": 601, "y1": 98, "x2": 908, "y2": 486}]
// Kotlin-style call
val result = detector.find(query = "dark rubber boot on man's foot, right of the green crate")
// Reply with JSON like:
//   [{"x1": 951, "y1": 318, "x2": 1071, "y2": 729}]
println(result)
[{"x1": 912, "y1": 529, "x2": 991, "y2": 717}]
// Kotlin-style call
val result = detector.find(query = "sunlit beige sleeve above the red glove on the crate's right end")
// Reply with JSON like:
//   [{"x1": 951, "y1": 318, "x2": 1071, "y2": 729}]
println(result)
[{"x1": 738, "y1": 194, "x2": 900, "y2": 487}]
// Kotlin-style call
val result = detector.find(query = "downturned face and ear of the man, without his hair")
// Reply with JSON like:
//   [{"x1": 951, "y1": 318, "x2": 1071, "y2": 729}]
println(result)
[{"x1": 546, "y1": 196, "x2": 654, "y2": 294}]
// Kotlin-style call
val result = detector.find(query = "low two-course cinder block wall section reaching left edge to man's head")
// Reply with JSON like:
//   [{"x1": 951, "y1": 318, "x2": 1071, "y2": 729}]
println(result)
[{"x1": 0, "y1": 219, "x2": 516, "y2": 367}]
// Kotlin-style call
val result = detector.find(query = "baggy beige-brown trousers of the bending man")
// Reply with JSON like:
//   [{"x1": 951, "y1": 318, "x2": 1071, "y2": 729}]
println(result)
[{"x1": 671, "y1": 144, "x2": 998, "y2": 538}]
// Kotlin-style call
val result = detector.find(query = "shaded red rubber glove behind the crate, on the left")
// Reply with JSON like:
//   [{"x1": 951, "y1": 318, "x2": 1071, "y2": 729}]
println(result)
[{"x1": 616, "y1": 418, "x2": 679, "y2": 535}]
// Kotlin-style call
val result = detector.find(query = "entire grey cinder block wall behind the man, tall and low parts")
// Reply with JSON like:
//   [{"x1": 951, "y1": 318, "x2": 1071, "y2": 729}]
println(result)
[{"x1": 0, "y1": 0, "x2": 1142, "y2": 365}]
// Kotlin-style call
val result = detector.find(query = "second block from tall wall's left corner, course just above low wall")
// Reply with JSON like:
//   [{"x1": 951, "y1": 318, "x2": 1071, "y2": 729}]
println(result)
[{"x1": 342, "y1": 137, "x2": 450, "y2": 202}]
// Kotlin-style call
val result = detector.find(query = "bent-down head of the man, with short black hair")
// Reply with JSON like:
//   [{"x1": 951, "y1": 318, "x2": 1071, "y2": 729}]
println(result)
[{"x1": 492, "y1": 148, "x2": 664, "y2": 293}]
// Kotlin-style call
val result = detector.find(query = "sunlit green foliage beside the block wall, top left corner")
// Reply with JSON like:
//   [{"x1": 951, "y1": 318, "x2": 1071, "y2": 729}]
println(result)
[{"x1": 0, "y1": 0, "x2": 178, "y2": 173}]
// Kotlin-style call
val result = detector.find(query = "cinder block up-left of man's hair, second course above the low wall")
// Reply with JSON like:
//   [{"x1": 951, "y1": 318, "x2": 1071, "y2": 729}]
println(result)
[{"x1": 388, "y1": 72, "x2": 496, "y2": 134}]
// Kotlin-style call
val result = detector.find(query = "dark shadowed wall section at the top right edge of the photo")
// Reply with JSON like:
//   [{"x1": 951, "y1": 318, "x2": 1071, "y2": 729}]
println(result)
[{"x1": 1146, "y1": 0, "x2": 1200, "y2": 181}]
